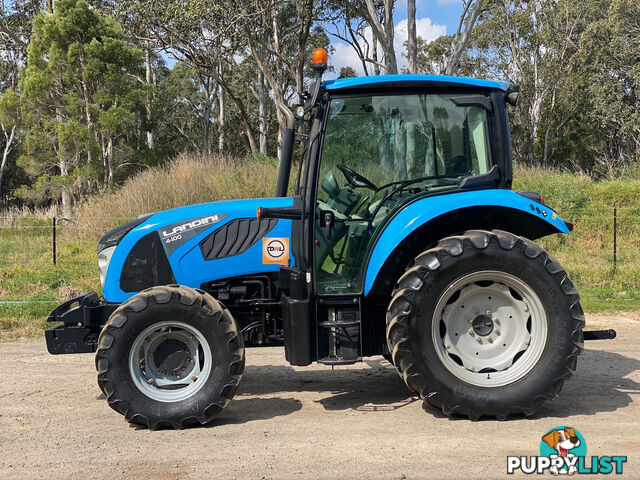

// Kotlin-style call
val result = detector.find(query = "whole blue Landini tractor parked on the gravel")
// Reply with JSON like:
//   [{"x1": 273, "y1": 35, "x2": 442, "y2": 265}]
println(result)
[{"x1": 46, "y1": 51, "x2": 614, "y2": 429}]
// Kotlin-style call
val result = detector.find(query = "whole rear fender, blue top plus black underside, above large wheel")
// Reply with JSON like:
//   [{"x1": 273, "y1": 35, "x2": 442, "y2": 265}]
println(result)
[{"x1": 364, "y1": 189, "x2": 572, "y2": 295}]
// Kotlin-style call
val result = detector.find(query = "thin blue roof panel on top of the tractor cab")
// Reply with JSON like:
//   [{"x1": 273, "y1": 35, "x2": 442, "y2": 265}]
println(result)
[{"x1": 322, "y1": 75, "x2": 509, "y2": 91}]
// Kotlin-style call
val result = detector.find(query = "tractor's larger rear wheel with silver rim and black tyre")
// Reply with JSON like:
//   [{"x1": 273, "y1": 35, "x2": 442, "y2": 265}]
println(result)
[{"x1": 387, "y1": 230, "x2": 584, "y2": 419}]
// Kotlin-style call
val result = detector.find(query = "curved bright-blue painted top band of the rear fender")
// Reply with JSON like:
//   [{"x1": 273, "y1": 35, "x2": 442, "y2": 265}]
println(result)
[{"x1": 364, "y1": 189, "x2": 569, "y2": 295}]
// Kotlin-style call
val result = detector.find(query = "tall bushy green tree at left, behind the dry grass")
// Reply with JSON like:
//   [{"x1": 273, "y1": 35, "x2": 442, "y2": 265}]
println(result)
[{"x1": 19, "y1": 0, "x2": 150, "y2": 216}]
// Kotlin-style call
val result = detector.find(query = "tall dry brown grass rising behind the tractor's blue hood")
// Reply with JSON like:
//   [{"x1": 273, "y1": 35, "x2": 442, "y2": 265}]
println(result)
[{"x1": 75, "y1": 155, "x2": 277, "y2": 236}]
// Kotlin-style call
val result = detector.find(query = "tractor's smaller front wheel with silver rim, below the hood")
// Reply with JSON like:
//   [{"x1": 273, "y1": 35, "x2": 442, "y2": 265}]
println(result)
[{"x1": 96, "y1": 285, "x2": 244, "y2": 429}]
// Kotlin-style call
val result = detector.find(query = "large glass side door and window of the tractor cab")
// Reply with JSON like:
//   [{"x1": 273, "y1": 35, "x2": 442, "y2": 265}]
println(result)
[{"x1": 314, "y1": 94, "x2": 492, "y2": 294}]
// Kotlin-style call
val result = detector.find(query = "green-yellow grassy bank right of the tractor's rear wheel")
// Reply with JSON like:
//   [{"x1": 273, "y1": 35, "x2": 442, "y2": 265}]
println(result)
[{"x1": 514, "y1": 168, "x2": 640, "y2": 312}]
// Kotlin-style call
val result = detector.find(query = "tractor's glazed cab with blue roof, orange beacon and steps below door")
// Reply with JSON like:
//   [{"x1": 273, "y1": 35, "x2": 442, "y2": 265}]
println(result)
[{"x1": 260, "y1": 51, "x2": 517, "y2": 365}]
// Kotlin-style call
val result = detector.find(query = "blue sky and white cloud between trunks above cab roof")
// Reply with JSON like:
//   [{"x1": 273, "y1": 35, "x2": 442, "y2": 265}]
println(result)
[{"x1": 325, "y1": 0, "x2": 462, "y2": 79}]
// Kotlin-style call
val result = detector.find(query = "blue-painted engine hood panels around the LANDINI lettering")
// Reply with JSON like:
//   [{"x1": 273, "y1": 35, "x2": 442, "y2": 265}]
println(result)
[{"x1": 103, "y1": 197, "x2": 295, "y2": 303}]
